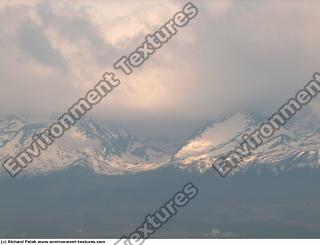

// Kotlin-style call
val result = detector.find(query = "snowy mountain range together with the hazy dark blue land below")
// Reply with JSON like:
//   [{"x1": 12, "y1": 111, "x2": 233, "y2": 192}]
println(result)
[{"x1": 0, "y1": 110, "x2": 320, "y2": 239}]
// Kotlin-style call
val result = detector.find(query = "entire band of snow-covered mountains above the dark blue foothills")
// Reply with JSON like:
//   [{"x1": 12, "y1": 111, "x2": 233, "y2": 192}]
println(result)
[{"x1": 0, "y1": 111, "x2": 320, "y2": 175}]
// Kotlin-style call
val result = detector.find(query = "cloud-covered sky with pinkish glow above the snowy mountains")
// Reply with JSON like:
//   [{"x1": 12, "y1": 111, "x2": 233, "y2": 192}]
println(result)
[{"x1": 0, "y1": 0, "x2": 320, "y2": 126}]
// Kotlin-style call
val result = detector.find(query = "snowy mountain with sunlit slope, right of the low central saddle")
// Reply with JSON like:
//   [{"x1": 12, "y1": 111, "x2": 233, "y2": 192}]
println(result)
[{"x1": 172, "y1": 113, "x2": 320, "y2": 172}]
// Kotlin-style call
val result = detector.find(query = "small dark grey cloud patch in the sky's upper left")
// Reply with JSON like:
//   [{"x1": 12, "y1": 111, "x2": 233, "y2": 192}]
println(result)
[{"x1": 17, "y1": 20, "x2": 66, "y2": 69}]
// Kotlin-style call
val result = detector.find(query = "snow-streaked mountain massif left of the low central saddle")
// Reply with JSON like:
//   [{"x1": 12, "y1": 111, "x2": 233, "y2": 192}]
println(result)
[{"x1": 0, "y1": 118, "x2": 169, "y2": 175}]
